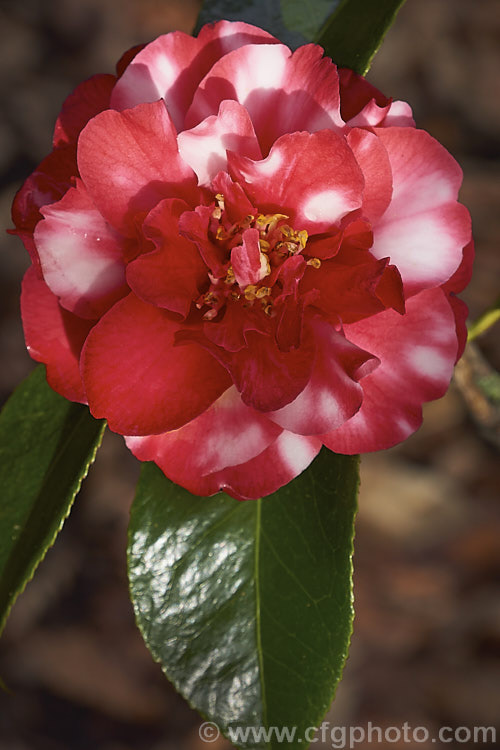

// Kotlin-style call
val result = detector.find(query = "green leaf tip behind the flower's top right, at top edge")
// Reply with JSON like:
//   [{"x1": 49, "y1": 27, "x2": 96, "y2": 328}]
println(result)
[{"x1": 317, "y1": 0, "x2": 405, "y2": 75}]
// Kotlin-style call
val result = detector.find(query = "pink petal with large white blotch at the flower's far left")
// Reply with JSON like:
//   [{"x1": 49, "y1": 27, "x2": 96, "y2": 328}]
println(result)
[{"x1": 34, "y1": 182, "x2": 128, "y2": 319}]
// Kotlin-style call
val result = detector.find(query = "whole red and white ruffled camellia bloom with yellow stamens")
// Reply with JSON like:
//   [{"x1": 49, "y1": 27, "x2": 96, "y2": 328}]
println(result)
[{"x1": 13, "y1": 21, "x2": 472, "y2": 499}]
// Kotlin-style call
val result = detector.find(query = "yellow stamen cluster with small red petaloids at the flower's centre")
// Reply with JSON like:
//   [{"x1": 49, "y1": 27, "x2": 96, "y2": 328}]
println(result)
[{"x1": 196, "y1": 193, "x2": 321, "y2": 320}]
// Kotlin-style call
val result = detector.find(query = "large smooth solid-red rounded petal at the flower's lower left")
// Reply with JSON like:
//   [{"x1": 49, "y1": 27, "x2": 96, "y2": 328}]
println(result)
[{"x1": 82, "y1": 294, "x2": 230, "y2": 435}]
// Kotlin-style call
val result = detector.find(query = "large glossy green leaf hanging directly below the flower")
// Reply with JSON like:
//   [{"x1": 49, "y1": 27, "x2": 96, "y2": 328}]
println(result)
[{"x1": 128, "y1": 450, "x2": 358, "y2": 750}]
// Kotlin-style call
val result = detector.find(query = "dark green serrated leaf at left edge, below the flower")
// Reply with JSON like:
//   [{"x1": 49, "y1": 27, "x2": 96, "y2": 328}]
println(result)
[{"x1": 0, "y1": 365, "x2": 105, "y2": 631}]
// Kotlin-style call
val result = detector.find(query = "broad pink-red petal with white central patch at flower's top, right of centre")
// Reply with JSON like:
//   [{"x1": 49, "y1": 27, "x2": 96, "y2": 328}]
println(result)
[{"x1": 186, "y1": 44, "x2": 344, "y2": 154}]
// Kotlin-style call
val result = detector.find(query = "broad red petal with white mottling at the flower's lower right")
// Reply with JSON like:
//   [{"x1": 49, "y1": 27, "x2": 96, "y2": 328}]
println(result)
[{"x1": 322, "y1": 289, "x2": 457, "y2": 453}]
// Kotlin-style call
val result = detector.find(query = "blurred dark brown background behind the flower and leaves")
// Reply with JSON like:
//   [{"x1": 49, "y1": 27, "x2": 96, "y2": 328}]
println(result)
[{"x1": 0, "y1": 0, "x2": 500, "y2": 750}]
